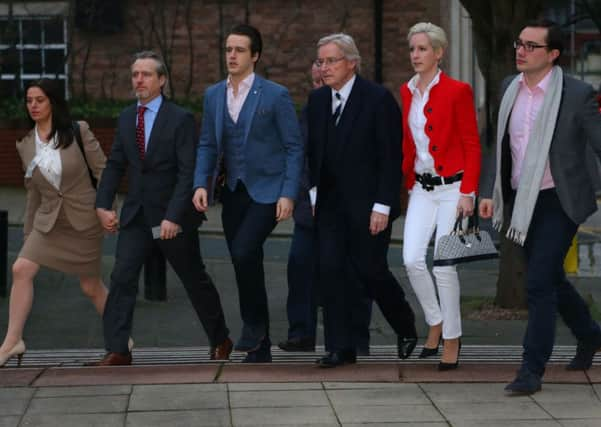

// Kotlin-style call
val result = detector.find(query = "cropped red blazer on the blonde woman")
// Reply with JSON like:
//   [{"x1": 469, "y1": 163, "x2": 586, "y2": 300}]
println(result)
[{"x1": 401, "y1": 73, "x2": 481, "y2": 194}]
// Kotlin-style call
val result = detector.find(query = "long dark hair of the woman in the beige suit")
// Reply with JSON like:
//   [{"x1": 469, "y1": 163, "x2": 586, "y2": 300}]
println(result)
[{"x1": 24, "y1": 78, "x2": 73, "y2": 148}]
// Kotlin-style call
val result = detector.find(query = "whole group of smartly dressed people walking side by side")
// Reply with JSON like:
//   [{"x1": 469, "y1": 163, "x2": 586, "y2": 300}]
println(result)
[{"x1": 0, "y1": 20, "x2": 601, "y2": 394}]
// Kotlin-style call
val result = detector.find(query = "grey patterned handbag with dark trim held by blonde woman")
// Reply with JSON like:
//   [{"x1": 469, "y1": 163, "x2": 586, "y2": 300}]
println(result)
[{"x1": 434, "y1": 212, "x2": 499, "y2": 266}]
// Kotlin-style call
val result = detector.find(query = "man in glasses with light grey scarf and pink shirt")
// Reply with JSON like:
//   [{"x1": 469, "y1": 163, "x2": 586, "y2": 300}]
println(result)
[{"x1": 479, "y1": 20, "x2": 601, "y2": 395}]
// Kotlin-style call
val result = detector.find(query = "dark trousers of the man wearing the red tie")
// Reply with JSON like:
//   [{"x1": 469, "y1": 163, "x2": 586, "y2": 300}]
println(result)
[{"x1": 103, "y1": 210, "x2": 229, "y2": 353}]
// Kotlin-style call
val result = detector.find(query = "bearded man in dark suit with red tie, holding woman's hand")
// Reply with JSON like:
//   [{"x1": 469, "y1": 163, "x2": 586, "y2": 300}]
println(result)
[{"x1": 91, "y1": 51, "x2": 233, "y2": 365}]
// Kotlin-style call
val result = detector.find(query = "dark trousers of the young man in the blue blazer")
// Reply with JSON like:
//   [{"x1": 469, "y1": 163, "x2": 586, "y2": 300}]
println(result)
[{"x1": 221, "y1": 181, "x2": 276, "y2": 342}]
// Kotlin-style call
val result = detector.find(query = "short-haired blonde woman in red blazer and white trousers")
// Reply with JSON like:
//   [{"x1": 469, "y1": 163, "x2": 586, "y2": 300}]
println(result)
[{"x1": 401, "y1": 22, "x2": 480, "y2": 370}]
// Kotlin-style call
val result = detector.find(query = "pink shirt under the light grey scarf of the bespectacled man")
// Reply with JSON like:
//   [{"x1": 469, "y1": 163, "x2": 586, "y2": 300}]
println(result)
[{"x1": 509, "y1": 71, "x2": 555, "y2": 190}]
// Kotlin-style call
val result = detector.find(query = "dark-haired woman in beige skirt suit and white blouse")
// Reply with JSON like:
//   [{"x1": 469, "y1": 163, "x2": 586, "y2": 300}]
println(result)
[{"x1": 0, "y1": 79, "x2": 107, "y2": 366}]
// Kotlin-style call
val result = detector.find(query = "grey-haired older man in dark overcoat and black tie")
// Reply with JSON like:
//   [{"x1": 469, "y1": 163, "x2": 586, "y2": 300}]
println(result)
[{"x1": 307, "y1": 34, "x2": 417, "y2": 368}]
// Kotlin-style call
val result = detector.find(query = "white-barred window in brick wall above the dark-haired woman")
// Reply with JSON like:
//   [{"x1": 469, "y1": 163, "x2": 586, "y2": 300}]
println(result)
[{"x1": 0, "y1": 2, "x2": 69, "y2": 97}]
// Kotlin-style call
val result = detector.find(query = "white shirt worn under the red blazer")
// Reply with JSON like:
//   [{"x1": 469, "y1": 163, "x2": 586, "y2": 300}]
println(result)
[{"x1": 407, "y1": 70, "x2": 440, "y2": 176}]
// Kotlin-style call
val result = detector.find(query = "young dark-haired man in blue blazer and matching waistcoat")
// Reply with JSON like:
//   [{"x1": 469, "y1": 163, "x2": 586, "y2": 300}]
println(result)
[{"x1": 193, "y1": 25, "x2": 303, "y2": 363}]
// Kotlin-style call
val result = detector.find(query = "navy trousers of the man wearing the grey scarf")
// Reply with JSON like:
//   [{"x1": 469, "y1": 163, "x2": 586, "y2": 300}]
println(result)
[{"x1": 522, "y1": 189, "x2": 601, "y2": 376}]
